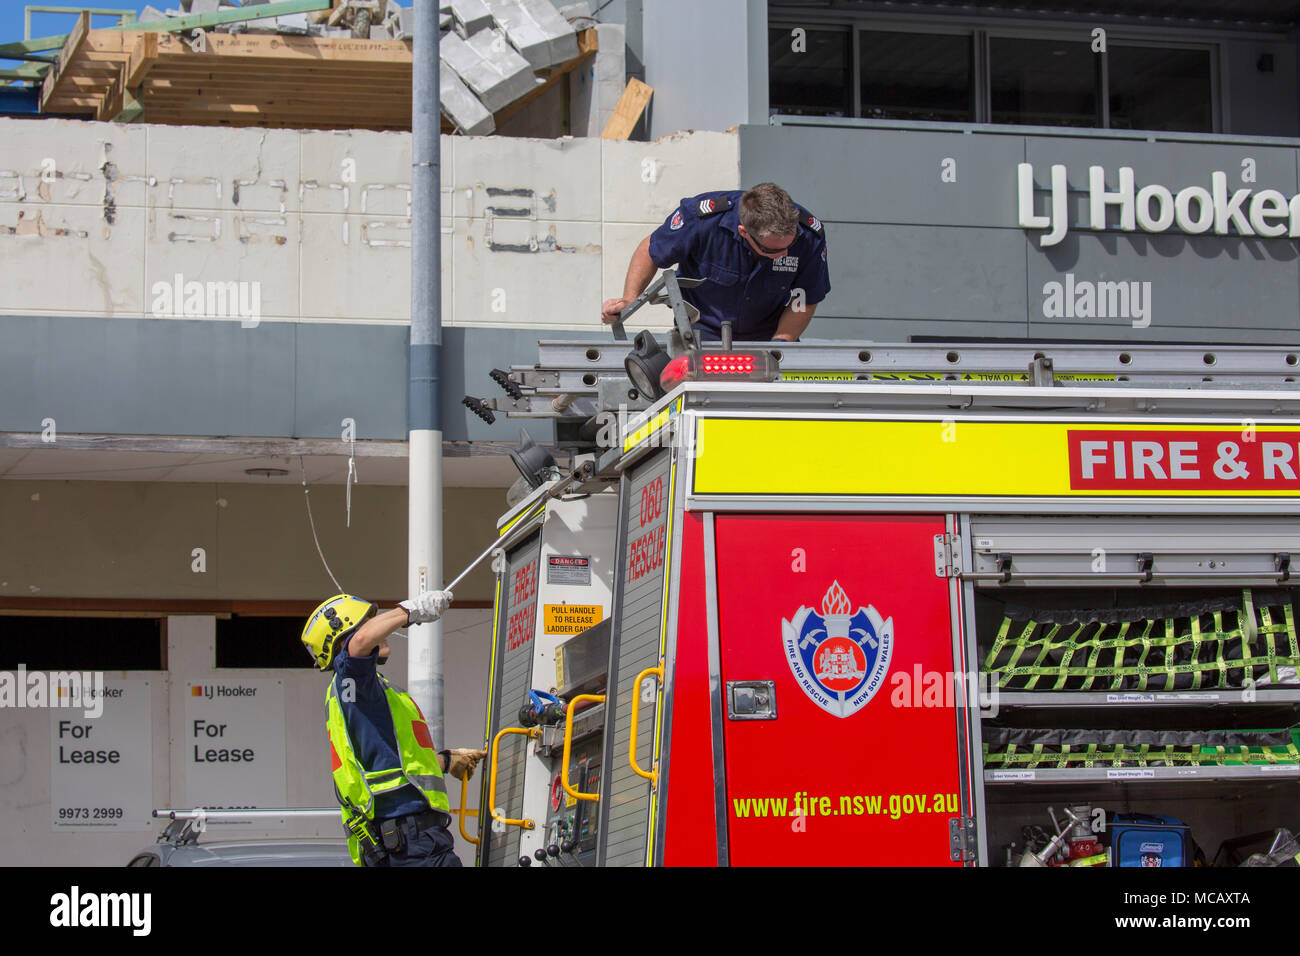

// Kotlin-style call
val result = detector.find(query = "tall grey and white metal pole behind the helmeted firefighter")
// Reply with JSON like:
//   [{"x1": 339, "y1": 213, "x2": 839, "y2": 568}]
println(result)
[{"x1": 407, "y1": 0, "x2": 443, "y2": 748}]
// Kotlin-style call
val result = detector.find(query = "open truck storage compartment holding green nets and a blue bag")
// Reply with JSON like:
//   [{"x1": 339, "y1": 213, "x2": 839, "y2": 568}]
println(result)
[{"x1": 967, "y1": 554, "x2": 1300, "y2": 866}]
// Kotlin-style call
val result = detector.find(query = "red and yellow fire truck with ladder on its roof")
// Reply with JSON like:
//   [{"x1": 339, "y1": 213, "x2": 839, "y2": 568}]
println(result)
[{"x1": 472, "y1": 280, "x2": 1300, "y2": 866}]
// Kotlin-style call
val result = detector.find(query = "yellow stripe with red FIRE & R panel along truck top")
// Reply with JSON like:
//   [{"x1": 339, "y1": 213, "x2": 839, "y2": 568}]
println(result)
[{"x1": 694, "y1": 418, "x2": 1300, "y2": 498}]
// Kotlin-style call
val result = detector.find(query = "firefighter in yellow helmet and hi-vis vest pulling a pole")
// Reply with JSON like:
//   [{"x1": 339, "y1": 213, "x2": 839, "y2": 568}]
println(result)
[{"x1": 303, "y1": 591, "x2": 485, "y2": 866}]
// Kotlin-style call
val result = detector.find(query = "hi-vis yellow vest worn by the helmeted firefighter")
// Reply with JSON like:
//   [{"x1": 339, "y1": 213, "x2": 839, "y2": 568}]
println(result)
[{"x1": 325, "y1": 674, "x2": 451, "y2": 862}]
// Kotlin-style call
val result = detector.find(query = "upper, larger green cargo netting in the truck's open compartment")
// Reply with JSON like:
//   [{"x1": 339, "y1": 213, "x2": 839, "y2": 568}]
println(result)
[{"x1": 984, "y1": 591, "x2": 1300, "y2": 691}]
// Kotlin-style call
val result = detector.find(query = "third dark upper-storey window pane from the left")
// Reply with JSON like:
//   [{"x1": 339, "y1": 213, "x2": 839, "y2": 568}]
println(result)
[{"x1": 988, "y1": 36, "x2": 1097, "y2": 126}]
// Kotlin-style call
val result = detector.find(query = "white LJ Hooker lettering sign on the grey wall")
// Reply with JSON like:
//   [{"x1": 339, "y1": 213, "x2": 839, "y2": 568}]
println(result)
[{"x1": 1017, "y1": 163, "x2": 1300, "y2": 247}]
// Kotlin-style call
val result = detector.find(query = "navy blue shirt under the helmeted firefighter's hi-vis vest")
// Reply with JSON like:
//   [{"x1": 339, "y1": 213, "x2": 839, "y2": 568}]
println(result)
[{"x1": 334, "y1": 639, "x2": 429, "y2": 819}]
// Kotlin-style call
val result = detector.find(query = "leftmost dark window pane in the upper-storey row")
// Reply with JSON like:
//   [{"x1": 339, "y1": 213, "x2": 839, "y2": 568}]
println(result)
[{"x1": 769, "y1": 26, "x2": 853, "y2": 116}]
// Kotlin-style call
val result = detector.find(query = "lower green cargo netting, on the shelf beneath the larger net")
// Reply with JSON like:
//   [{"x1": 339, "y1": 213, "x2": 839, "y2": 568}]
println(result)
[{"x1": 984, "y1": 727, "x2": 1300, "y2": 770}]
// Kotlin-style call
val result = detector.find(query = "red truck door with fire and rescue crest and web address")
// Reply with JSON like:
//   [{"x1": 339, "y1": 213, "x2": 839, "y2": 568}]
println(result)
[{"x1": 706, "y1": 515, "x2": 959, "y2": 865}]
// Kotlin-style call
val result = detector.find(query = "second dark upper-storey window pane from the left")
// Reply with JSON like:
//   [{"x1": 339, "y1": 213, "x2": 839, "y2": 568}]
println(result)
[{"x1": 858, "y1": 30, "x2": 975, "y2": 122}]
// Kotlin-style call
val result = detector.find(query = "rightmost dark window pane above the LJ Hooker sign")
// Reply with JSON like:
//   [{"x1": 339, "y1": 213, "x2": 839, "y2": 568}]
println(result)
[{"x1": 1106, "y1": 46, "x2": 1214, "y2": 133}]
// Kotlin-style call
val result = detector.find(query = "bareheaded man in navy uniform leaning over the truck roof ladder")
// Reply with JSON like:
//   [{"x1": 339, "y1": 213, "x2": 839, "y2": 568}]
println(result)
[{"x1": 601, "y1": 182, "x2": 831, "y2": 342}]
